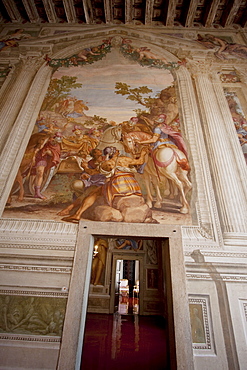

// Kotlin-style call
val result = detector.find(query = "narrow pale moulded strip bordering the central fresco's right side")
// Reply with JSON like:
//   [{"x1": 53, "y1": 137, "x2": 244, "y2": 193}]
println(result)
[{"x1": 175, "y1": 66, "x2": 222, "y2": 246}]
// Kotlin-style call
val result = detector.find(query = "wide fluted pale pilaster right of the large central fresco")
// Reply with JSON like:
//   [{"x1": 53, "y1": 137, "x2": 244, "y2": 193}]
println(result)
[{"x1": 191, "y1": 62, "x2": 247, "y2": 244}]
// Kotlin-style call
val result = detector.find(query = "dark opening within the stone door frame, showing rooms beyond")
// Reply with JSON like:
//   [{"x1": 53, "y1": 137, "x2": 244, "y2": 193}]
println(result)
[{"x1": 81, "y1": 237, "x2": 170, "y2": 370}]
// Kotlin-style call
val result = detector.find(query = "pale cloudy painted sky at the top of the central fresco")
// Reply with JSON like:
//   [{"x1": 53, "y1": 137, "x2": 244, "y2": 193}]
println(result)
[{"x1": 53, "y1": 49, "x2": 173, "y2": 123}]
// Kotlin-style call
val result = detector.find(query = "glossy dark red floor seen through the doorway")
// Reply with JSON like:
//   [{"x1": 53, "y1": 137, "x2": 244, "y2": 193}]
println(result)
[{"x1": 81, "y1": 313, "x2": 169, "y2": 370}]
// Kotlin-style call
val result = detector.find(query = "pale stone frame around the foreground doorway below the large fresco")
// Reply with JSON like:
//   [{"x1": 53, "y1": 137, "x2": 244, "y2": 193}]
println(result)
[{"x1": 57, "y1": 220, "x2": 194, "y2": 370}]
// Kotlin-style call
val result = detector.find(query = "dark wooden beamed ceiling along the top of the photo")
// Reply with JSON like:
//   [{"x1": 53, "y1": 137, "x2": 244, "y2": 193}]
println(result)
[{"x1": 0, "y1": 0, "x2": 247, "y2": 29}]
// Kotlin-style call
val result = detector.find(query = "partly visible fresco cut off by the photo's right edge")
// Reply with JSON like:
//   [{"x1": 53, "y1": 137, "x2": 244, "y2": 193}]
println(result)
[{"x1": 225, "y1": 91, "x2": 247, "y2": 164}]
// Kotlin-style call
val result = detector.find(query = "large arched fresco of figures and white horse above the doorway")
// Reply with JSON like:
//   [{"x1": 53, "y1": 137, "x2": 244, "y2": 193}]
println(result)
[{"x1": 3, "y1": 38, "x2": 192, "y2": 224}]
